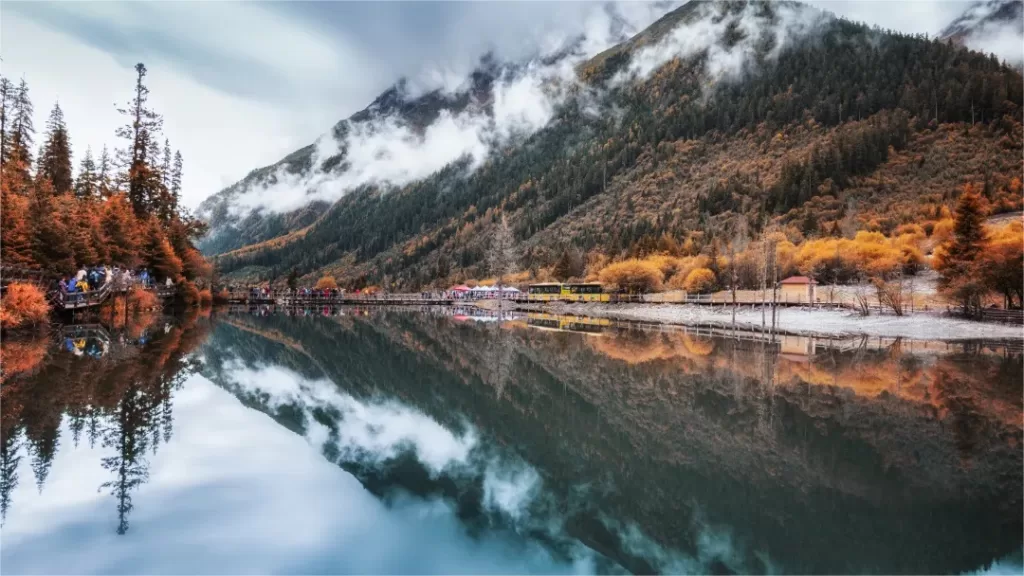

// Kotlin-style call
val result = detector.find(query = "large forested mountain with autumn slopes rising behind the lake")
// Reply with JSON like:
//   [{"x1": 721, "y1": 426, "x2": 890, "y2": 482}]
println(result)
[{"x1": 200, "y1": 2, "x2": 1022, "y2": 289}]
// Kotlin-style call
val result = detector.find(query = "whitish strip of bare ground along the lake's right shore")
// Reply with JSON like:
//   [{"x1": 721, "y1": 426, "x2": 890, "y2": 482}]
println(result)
[{"x1": 520, "y1": 303, "x2": 1024, "y2": 340}]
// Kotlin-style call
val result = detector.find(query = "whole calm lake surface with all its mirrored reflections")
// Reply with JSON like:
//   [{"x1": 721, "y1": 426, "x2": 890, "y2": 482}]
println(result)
[{"x1": 0, "y1": 308, "x2": 1024, "y2": 574}]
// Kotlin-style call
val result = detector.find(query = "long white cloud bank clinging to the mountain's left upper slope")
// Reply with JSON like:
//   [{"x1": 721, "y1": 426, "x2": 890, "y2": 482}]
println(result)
[{"x1": 220, "y1": 3, "x2": 684, "y2": 217}]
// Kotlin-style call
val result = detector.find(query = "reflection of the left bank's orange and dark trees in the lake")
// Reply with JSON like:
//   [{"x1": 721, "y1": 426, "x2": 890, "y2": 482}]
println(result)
[{"x1": 0, "y1": 313, "x2": 209, "y2": 534}]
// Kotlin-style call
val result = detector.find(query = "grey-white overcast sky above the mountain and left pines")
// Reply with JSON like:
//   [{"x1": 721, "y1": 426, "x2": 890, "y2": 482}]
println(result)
[{"x1": 0, "y1": 0, "x2": 967, "y2": 206}]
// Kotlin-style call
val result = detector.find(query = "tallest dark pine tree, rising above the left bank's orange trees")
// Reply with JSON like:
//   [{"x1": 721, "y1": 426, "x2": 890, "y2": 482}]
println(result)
[{"x1": 117, "y1": 63, "x2": 163, "y2": 217}]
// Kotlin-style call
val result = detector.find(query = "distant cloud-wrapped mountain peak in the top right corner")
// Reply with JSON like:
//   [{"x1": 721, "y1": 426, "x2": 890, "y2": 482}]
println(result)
[{"x1": 939, "y1": 0, "x2": 1024, "y2": 68}]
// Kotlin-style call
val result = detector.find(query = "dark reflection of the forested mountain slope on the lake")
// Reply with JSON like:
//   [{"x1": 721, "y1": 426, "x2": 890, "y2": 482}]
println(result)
[{"x1": 204, "y1": 308, "x2": 1024, "y2": 573}]
